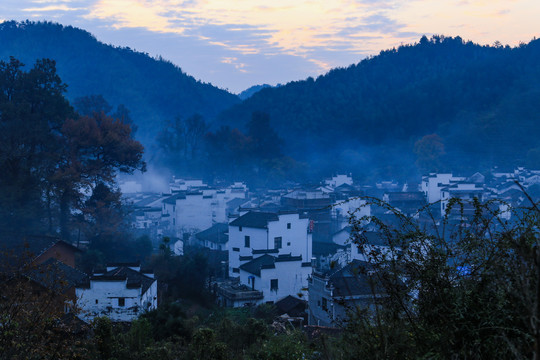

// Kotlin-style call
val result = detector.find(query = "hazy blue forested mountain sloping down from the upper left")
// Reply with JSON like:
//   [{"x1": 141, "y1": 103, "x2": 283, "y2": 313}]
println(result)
[{"x1": 0, "y1": 21, "x2": 240, "y2": 145}]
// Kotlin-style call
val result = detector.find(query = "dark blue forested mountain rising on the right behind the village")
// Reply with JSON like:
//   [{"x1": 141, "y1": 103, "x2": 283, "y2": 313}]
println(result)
[{"x1": 220, "y1": 36, "x2": 540, "y2": 176}]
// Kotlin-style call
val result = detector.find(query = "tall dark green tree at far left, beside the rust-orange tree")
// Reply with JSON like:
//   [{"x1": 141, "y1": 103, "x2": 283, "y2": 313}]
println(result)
[{"x1": 0, "y1": 58, "x2": 73, "y2": 236}]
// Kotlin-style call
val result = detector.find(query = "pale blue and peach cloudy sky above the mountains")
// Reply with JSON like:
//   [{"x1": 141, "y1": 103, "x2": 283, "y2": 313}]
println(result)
[{"x1": 0, "y1": 0, "x2": 540, "y2": 93}]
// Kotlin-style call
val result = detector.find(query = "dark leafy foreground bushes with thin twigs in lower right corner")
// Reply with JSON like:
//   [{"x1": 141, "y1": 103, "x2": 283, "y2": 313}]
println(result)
[{"x1": 336, "y1": 199, "x2": 540, "y2": 359}]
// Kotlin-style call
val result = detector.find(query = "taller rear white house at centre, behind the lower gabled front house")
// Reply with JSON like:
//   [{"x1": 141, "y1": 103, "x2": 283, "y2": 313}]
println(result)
[{"x1": 227, "y1": 211, "x2": 313, "y2": 277}]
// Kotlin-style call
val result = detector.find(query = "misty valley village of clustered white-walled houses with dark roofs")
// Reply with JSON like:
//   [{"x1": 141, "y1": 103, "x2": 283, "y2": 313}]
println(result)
[{"x1": 116, "y1": 168, "x2": 540, "y2": 324}]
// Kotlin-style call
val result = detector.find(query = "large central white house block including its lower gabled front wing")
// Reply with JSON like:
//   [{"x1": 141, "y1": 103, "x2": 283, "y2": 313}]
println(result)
[{"x1": 227, "y1": 211, "x2": 312, "y2": 304}]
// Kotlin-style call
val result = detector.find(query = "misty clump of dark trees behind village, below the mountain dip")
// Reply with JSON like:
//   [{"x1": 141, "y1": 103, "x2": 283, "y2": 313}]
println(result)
[{"x1": 152, "y1": 112, "x2": 306, "y2": 187}]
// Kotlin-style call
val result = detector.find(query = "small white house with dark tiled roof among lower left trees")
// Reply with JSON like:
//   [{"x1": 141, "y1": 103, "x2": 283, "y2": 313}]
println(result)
[{"x1": 75, "y1": 264, "x2": 158, "y2": 322}]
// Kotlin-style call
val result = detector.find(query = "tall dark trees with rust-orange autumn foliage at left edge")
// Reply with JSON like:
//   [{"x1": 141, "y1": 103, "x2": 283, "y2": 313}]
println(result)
[{"x1": 0, "y1": 57, "x2": 151, "y2": 260}]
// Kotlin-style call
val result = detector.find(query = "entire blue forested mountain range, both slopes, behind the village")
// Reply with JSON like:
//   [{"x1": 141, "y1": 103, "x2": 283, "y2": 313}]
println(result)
[{"x1": 4, "y1": 22, "x2": 540, "y2": 178}]
